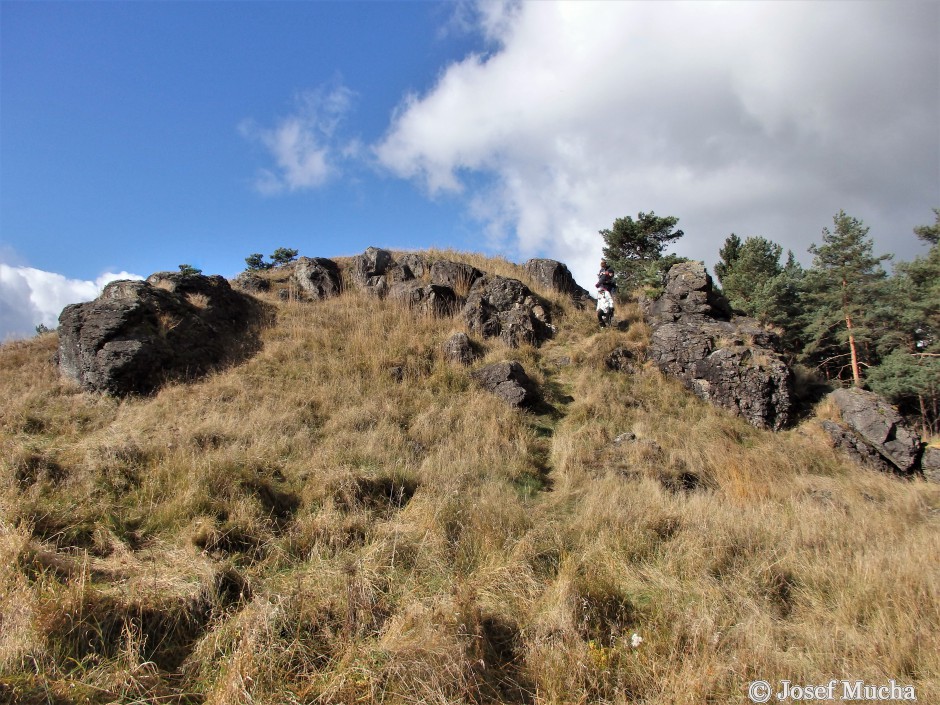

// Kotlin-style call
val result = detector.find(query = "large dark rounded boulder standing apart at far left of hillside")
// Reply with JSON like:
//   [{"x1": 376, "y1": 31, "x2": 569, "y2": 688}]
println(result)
[{"x1": 57, "y1": 272, "x2": 264, "y2": 395}]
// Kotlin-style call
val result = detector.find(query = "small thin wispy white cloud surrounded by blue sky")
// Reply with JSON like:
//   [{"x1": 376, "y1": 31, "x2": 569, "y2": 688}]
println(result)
[{"x1": 239, "y1": 85, "x2": 357, "y2": 195}]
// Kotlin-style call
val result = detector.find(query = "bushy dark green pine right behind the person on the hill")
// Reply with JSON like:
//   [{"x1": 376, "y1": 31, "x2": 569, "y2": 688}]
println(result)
[{"x1": 599, "y1": 211, "x2": 684, "y2": 293}]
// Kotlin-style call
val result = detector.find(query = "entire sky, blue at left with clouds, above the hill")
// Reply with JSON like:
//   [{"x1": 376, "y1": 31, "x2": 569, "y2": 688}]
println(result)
[{"x1": 0, "y1": 0, "x2": 940, "y2": 340}]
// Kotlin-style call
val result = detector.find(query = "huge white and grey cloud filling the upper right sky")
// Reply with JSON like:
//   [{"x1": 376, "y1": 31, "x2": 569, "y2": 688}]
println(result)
[{"x1": 374, "y1": 1, "x2": 940, "y2": 284}]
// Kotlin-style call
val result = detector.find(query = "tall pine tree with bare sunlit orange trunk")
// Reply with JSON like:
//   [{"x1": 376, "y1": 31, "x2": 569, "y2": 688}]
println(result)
[{"x1": 804, "y1": 211, "x2": 892, "y2": 386}]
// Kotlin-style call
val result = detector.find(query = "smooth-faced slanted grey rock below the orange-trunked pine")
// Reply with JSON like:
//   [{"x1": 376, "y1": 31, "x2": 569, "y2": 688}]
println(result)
[{"x1": 823, "y1": 387, "x2": 923, "y2": 475}]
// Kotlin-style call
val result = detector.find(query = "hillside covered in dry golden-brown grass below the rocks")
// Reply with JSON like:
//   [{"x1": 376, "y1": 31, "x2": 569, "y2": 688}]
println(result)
[{"x1": 0, "y1": 253, "x2": 940, "y2": 705}]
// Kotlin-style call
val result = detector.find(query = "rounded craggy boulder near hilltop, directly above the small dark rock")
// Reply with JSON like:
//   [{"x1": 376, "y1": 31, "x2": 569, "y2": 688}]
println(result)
[{"x1": 462, "y1": 275, "x2": 554, "y2": 348}]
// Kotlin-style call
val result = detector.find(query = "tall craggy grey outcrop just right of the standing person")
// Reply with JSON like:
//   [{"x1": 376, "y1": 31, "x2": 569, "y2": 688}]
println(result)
[{"x1": 645, "y1": 262, "x2": 793, "y2": 430}]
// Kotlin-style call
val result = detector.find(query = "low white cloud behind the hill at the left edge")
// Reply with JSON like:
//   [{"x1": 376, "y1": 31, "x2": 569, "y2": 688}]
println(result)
[{"x1": 0, "y1": 263, "x2": 143, "y2": 342}]
